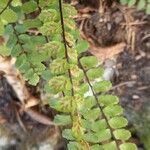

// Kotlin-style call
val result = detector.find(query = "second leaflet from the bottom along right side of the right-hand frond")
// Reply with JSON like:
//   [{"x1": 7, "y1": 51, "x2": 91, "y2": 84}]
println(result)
[{"x1": 113, "y1": 129, "x2": 131, "y2": 141}]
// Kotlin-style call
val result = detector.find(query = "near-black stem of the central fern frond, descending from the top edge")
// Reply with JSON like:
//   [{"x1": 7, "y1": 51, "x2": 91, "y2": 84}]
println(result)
[{"x1": 59, "y1": 0, "x2": 74, "y2": 96}]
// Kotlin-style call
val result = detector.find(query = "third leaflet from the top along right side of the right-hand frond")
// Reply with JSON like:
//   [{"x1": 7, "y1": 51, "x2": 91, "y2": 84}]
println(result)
[{"x1": 93, "y1": 81, "x2": 112, "y2": 93}]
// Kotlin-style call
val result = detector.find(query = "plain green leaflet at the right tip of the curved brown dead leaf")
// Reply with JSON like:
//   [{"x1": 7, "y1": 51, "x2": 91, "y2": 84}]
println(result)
[{"x1": 54, "y1": 115, "x2": 71, "y2": 125}]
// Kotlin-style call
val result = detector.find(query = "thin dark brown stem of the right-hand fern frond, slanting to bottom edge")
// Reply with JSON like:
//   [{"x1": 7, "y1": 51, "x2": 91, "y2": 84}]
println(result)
[{"x1": 79, "y1": 60, "x2": 119, "y2": 150}]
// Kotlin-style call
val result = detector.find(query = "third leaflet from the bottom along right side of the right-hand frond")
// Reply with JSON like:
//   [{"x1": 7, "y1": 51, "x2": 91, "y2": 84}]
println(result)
[{"x1": 109, "y1": 117, "x2": 128, "y2": 129}]
